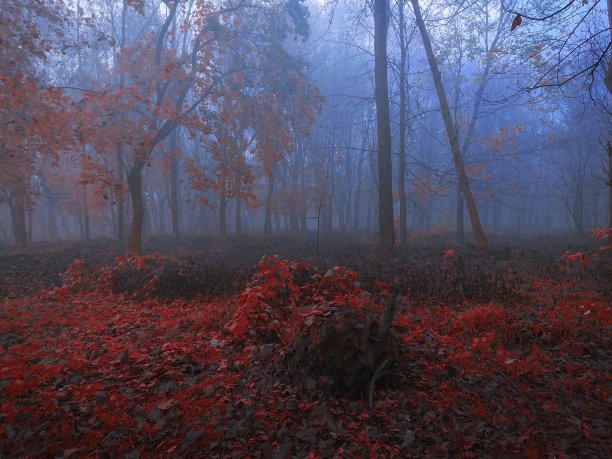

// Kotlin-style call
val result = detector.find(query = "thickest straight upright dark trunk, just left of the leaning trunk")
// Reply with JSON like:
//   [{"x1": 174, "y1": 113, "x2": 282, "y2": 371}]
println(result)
[{"x1": 374, "y1": 0, "x2": 395, "y2": 247}]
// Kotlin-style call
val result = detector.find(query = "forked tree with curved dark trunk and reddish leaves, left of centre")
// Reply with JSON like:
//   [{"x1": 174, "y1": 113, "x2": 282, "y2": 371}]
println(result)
[{"x1": 80, "y1": 0, "x2": 304, "y2": 253}]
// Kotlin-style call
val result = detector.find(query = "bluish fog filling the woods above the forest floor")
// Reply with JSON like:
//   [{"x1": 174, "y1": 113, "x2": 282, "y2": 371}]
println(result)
[{"x1": 0, "y1": 0, "x2": 612, "y2": 252}]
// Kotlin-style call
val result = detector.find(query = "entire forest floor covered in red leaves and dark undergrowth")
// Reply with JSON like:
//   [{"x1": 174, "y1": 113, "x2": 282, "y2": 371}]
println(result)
[{"x1": 0, "y1": 236, "x2": 612, "y2": 458}]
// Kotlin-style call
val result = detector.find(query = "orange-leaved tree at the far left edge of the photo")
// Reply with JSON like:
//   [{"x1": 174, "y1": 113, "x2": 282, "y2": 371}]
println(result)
[{"x1": 0, "y1": 0, "x2": 73, "y2": 246}]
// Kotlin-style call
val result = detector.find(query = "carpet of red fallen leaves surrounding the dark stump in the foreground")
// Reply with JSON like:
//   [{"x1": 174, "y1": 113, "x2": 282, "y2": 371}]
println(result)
[{"x1": 0, "y1": 258, "x2": 612, "y2": 457}]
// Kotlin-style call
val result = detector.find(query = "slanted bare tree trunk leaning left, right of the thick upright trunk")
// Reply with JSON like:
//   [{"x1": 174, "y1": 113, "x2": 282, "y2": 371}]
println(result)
[{"x1": 410, "y1": 0, "x2": 487, "y2": 249}]
